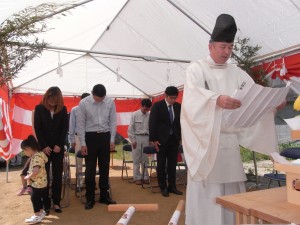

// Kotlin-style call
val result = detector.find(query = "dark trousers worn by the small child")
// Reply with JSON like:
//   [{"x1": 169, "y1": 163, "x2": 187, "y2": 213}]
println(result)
[{"x1": 31, "y1": 187, "x2": 51, "y2": 213}]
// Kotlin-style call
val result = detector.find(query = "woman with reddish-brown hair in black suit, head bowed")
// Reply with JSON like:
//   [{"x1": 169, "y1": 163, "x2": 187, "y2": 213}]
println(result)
[{"x1": 34, "y1": 87, "x2": 68, "y2": 213}]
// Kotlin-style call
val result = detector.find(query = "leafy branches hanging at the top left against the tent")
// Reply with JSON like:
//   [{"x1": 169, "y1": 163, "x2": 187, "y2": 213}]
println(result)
[{"x1": 0, "y1": 3, "x2": 75, "y2": 85}]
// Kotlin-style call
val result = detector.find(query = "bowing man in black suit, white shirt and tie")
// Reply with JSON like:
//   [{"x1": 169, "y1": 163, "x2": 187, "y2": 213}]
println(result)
[{"x1": 149, "y1": 86, "x2": 182, "y2": 197}]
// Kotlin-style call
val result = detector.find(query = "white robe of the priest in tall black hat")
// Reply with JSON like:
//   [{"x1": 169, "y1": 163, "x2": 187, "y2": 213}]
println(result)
[{"x1": 181, "y1": 56, "x2": 277, "y2": 225}]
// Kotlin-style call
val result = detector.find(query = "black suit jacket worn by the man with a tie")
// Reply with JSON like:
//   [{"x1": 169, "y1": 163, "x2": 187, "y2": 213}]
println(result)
[{"x1": 149, "y1": 99, "x2": 181, "y2": 145}]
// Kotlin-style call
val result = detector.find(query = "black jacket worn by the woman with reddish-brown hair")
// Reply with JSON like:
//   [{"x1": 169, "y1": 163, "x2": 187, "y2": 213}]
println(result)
[{"x1": 34, "y1": 104, "x2": 68, "y2": 152}]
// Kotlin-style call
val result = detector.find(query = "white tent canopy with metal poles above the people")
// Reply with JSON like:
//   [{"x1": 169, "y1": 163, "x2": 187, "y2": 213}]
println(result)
[{"x1": 0, "y1": 0, "x2": 300, "y2": 97}]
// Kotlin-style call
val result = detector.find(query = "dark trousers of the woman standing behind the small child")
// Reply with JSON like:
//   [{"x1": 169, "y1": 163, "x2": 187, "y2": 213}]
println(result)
[{"x1": 45, "y1": 149, "x2": 64, "y2": 205}]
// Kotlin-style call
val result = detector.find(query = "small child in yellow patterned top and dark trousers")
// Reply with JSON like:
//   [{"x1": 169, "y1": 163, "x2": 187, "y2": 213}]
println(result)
[{"x1": 21, "y1": 135, "x2": 51, "y2": 223}]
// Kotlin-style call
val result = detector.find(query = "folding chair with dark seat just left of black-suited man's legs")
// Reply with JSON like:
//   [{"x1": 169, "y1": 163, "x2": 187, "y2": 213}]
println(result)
[{"x1": 142, "y1": 146, "x2": 160, "y2": 193}]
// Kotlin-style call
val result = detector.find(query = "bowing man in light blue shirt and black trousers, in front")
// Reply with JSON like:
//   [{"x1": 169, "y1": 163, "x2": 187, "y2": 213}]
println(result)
[{"x1": 76, "y1": 84, "x2": 117, "y2": 209}]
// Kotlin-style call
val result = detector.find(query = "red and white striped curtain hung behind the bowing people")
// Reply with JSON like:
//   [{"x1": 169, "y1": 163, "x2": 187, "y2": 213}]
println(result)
[{"x1": 0, "y1": 88, "x2": 182, "y2": 160}]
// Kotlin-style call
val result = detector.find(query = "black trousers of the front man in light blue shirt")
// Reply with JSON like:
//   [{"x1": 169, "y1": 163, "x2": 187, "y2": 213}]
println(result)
[{"x1": 85, "y1": 132, "x2": 110, "y2": 202}]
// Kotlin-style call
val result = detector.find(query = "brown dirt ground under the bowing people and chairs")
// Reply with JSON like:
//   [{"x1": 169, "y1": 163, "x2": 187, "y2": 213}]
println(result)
[{"x1": 0, "y1": 156, "x2": 185, "y2": 225}]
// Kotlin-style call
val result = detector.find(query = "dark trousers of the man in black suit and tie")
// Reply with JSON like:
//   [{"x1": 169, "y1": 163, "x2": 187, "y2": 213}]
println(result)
[{"x1": 157, "y1": 135, "x2": 179, "y2": 190}]
